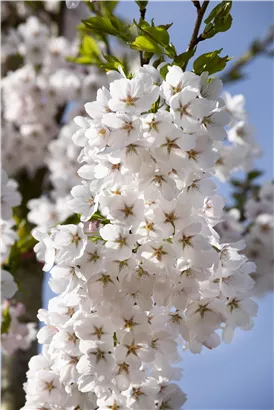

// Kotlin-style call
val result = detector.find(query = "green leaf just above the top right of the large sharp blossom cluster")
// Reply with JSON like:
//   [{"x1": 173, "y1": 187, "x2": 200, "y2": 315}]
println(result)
[{"x1": 193, "y1": 48, "x2": 231, "y2": 75}]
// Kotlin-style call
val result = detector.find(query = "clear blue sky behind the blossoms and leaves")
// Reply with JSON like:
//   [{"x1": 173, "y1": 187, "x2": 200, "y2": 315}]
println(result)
[{"x1": 45, "y1": 0, "x2": 274, "y2": 410}]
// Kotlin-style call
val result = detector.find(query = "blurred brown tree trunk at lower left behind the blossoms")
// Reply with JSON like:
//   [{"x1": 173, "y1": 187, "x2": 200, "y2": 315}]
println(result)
[{"x1": 0, "y1": 258, "x2": 43, "y2": 410}]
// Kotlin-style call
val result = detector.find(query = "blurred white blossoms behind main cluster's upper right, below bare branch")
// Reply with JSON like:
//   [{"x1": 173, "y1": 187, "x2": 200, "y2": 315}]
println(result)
[{"x1": 215, "y1": 92, "x2": 261, "y2": 182}]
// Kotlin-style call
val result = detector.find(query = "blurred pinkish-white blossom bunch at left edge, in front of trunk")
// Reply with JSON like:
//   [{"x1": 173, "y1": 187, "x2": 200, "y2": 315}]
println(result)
[{"x1": 0, "y1": 300, "x2": 37, "y2": 355}]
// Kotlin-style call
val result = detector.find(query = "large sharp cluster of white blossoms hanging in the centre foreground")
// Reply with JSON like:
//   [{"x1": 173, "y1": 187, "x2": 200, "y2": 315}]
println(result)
[{"x1": 24, "y1": 66, "x2": 257, "y2": 410}]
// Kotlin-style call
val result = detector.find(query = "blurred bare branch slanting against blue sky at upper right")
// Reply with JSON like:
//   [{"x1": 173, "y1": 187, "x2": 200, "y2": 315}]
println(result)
[{"x1": 221, "y1": 26, "x2": 274, "y2": 83}]
